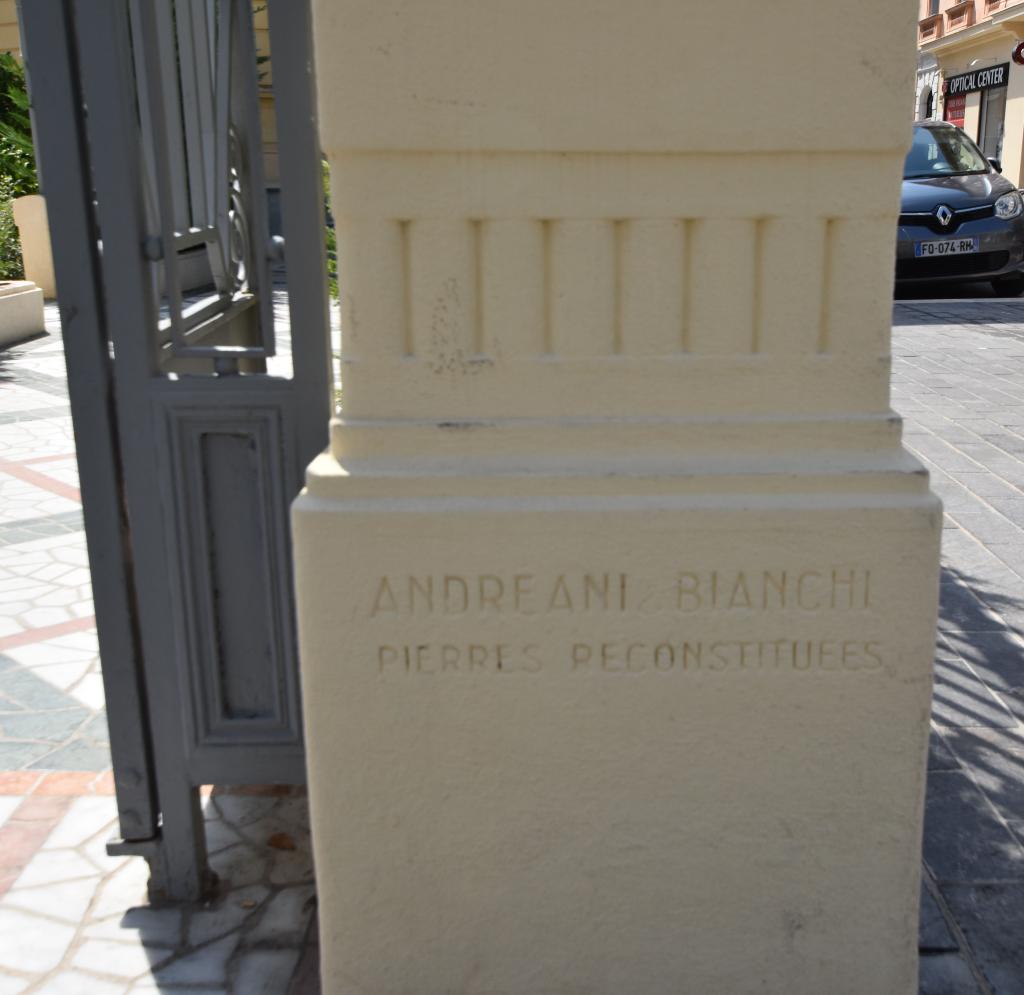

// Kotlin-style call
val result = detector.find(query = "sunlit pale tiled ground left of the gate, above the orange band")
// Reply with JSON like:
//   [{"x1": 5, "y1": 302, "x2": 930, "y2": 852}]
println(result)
[{"x1": 0, "y1": 319, "x2": 102, "y2": 773}]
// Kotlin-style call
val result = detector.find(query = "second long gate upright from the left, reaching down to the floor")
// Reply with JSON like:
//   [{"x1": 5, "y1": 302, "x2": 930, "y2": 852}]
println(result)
[{"x1": 72, "y1": 0, "x2": 209, "y2": 901}]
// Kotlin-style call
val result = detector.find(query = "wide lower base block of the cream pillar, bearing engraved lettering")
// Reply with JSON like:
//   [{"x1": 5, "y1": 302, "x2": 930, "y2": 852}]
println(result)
[{"x1": 294, "y1": 450, "x2": 941, "y2": 995}]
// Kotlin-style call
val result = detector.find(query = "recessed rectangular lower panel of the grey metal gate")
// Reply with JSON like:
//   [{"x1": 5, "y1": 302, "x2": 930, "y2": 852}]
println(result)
[{"x1": 153, "y1": 385, "x2": 302, "y2": 753}]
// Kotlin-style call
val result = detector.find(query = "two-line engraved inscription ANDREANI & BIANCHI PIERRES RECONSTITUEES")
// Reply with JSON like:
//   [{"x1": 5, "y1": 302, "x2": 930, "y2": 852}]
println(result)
[{"x1": 367, "y1": 565, "x2": 885, "y2": 675}]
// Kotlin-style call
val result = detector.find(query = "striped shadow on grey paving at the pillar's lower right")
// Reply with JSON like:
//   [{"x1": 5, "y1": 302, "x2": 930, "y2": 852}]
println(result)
[{"x1": 920, "y1": 568, "x2": 1024, "y2": 995}]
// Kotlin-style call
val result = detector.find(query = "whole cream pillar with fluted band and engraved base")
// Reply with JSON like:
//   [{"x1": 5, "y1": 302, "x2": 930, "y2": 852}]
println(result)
[{"x1": 294, "y1": 0, "x2": 940, "y2": 995}]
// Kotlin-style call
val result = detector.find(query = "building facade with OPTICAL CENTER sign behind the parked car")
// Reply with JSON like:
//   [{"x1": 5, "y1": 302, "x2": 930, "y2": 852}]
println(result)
[{"x1": 915, "y1": 0, "x2": 1024, "y2": 185}]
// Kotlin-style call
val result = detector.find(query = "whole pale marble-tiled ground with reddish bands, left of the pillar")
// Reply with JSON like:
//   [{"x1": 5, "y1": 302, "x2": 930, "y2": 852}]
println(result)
[{"x1": 0, "y1": 305, "x2": 314, "y2": 995}]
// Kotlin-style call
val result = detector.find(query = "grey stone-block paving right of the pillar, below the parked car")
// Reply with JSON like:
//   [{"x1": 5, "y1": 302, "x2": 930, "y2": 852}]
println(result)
[{"x1": 893, "y1": 300, "x2": 1024, "y2": 995}]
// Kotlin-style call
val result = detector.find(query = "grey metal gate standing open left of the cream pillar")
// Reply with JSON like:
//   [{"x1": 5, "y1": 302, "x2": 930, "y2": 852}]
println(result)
[{"x1": 20, "y1": 0, "x2": 332, "y2": 900}]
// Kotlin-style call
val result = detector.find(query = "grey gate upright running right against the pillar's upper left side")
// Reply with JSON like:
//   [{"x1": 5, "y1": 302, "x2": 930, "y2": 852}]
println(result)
[{"x1": 267, "y1": 0, "x2": 333, "y2": 465}]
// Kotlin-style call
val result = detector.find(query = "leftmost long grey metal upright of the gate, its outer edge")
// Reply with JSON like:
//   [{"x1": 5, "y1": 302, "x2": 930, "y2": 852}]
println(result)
[{"x1": 19, "y1": 0, "x2": 158, "y2": 840}]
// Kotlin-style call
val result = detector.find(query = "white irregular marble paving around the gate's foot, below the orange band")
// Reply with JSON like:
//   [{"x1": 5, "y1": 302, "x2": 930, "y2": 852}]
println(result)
[{"x1": 0, "y1": 775, "x2": 315, "y2": 995}]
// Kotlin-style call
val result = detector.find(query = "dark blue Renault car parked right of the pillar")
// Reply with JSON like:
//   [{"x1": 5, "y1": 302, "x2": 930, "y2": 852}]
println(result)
[{"x1": 896, "y1": 121, "x2": 1024, "y2": 296}]
